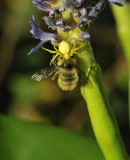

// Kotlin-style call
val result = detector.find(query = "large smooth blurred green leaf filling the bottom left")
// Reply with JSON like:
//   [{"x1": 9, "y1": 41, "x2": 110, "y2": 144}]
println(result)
[{"x1": 0, "y1": 116, "x2": 104, "y2": 160}]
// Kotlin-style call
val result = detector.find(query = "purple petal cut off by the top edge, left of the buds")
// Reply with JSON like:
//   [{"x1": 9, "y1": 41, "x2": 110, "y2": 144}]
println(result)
[{"x1": 32, "y1": 0, "x2": 52, "y2": 12}]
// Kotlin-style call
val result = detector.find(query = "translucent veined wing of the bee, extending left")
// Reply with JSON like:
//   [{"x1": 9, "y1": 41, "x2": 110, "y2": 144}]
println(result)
[{"x1": 31, "y1": 67, "x2": 57, "y2": 81}]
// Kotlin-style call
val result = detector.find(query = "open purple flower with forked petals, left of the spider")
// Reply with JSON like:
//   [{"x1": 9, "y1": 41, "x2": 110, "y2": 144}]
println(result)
[{"x1": 27, "y1": 16, "x2": 58, "y2": 55}]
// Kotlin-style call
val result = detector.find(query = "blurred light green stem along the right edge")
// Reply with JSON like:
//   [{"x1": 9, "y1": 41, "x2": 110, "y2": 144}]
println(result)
[{"x1": 112, "y1": 3, "x2": 130, "y2": 129}]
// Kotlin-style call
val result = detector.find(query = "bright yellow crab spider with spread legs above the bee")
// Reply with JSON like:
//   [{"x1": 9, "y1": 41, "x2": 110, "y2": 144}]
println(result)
[{"x1": 42, "y1": 41, "x2": 85, "y2": 66}]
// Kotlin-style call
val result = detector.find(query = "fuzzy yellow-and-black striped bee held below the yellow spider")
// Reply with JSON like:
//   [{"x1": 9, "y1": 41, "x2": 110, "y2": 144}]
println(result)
[{"x1": 31, "y1": 56, "x2": 87, "y2": 91}]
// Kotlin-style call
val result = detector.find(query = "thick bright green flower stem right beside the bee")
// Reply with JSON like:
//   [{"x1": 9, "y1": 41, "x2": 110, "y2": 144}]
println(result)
[{"x1": 79, "y1": 43, "x2": 128, "y2": 160}]
